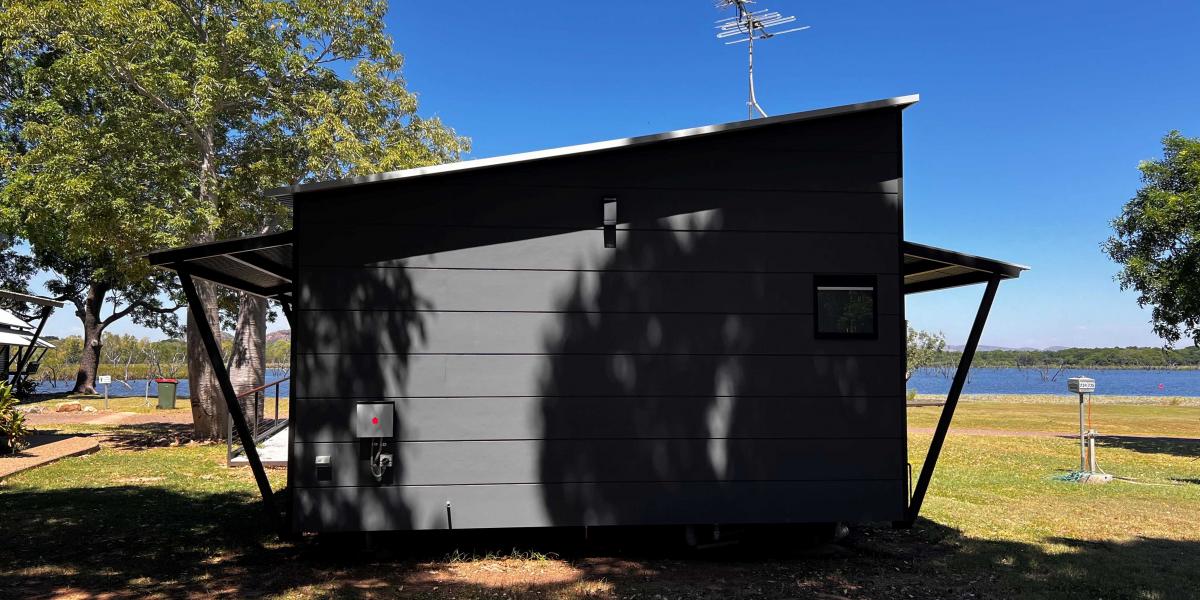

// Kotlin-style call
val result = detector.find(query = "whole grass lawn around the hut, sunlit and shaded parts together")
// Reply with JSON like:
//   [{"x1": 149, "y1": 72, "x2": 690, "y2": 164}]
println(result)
[{"x1": 0, "y1": 403, "x2": 1200, "y2": 599}]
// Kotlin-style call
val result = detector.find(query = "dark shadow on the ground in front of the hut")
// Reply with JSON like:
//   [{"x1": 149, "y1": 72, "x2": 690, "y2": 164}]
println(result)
[{"x1": 0, "y1": 486, "x2": 1200, "y2": 599}]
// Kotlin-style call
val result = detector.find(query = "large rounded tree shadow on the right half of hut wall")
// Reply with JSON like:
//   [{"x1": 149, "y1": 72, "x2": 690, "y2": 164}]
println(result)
[{"x1": 540, "y1": 211, "x2": 905, "y2": 526}]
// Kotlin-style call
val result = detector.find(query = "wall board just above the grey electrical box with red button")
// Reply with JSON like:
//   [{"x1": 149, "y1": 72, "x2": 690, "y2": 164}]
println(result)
[{"x1": 293, "y1": 354, "x2": 904, "y2": 398}]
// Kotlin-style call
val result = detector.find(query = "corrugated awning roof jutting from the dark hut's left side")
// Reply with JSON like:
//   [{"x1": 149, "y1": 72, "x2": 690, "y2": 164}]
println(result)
[{"x1": 146, "y1": 232, "x2": 295, "y2": 302}]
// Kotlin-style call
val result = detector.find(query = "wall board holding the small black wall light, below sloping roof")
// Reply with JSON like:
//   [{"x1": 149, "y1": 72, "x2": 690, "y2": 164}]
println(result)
[{"x1": 296, "y1": 184, "x2": 899, "y2": 233}]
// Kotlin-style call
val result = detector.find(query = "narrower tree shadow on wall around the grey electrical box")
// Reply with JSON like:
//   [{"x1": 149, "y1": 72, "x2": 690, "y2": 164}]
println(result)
[{"x1": 292, "y1": 265, "x2": 433, "y2": 529}]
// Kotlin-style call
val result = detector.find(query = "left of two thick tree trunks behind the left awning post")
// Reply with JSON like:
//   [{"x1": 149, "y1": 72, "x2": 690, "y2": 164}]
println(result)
[{"x1": 187, "y1": 280, "x2": 229, "y2": 439}]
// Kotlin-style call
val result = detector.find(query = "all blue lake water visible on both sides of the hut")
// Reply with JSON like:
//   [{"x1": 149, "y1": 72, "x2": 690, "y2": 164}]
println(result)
[{"x1": 37, "y1": 368, "x2": 1200, "y2": 397}]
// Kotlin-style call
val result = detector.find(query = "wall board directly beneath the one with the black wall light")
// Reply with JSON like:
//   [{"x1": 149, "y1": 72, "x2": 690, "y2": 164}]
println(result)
[{"x1": 296, "y1": 226, "x2": 900, "y2": 272}]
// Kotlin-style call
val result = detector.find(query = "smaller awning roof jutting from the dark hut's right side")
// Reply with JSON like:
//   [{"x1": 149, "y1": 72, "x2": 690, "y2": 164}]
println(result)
[{"x1": 904, "y1": 241, "x2": 1028, "y2": 294}]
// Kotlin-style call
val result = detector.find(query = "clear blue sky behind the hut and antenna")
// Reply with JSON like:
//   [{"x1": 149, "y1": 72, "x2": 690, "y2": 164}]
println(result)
[{"x1": 23, "y1": 0, "x2": 1200, "y2": 347}]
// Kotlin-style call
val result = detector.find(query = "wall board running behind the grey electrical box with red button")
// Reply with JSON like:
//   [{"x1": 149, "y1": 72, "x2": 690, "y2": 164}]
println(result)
[{"x1": 292, "y1": 396, "x2": 907, "y2": 443}]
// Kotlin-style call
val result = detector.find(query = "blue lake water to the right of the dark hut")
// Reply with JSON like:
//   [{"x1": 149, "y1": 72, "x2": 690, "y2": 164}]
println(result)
[{"x1": 908, "y1": 368, "x2": 1200, "y2": 396}]
